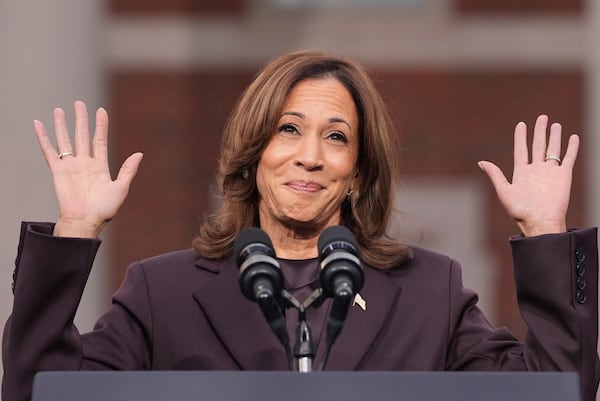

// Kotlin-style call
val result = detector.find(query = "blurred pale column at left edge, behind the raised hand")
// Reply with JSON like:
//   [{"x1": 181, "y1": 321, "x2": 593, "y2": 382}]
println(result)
[{"x1": 0, "y1": 0, "x2": 107, "y2": 335}]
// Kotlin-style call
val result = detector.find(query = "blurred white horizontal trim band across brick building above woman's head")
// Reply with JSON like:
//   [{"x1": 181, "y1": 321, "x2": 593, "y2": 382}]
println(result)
[{"x1": 105, "y1": 13, "x2": 585, "y2": 69}]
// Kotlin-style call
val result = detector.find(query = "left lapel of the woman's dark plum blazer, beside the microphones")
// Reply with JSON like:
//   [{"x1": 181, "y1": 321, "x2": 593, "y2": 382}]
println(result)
[{"x1": 193, "y1": 258, "x2": 288, "y2": 370}]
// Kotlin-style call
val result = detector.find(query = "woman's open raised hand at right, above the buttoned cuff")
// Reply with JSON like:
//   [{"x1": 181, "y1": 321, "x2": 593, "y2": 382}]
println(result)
[{"x1": 478, "y1": 115, "x2": 579, "y2": 236}]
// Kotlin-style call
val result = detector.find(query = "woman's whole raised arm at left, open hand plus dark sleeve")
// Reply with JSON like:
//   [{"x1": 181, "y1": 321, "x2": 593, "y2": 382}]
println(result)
[{"x1": 2, "y1": 101, "x2": 142, "y2": 401}]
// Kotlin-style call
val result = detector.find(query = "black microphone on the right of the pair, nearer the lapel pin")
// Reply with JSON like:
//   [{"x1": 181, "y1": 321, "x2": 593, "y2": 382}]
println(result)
[{"x1": 318, "y1": 226, "x2": 365, "y2": 354}]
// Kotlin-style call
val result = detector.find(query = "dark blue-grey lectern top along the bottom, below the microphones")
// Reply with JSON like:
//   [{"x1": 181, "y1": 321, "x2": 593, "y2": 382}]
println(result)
[{"x1": 32, "y1": 371, "x2": 581, "y2": 401}]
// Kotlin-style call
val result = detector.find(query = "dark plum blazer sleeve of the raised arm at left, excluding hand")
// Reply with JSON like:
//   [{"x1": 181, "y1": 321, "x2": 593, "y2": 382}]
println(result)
[{"x1": 2, "y1": 223, "x2": 100, "y2": 401}]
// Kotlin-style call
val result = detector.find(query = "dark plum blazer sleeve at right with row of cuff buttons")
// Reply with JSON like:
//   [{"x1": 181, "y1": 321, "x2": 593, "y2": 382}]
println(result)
[{"x1": 510, "y1": 228, "x2": 600, "y2": 400}]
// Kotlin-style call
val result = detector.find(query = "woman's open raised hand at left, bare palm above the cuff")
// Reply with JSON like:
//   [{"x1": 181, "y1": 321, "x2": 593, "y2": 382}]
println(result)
[{"x1": 34, "y1": 101, "x2": 142, "y2": 238}]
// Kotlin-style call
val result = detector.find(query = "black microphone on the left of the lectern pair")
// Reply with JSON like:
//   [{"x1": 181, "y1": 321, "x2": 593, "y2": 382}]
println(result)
[{"x1": 233, "y1": 227, "x2": 290, "y2": 350}]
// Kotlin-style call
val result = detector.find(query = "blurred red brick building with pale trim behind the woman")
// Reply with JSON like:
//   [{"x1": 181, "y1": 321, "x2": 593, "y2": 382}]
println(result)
[{"x1": 0, "y1": 0, "x2": 600, "y2": 382}]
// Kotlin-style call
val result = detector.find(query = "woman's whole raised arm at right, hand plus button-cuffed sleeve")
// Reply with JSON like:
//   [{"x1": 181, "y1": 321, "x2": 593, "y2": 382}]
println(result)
[{"x1": 479, "y1": 115, "x2": 598, "y2": 400}]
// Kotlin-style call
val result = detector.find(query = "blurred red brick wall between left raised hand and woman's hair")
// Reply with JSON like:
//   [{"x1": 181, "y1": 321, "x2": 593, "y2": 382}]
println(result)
[{"x1": 110, "y1": 71, "x2": 250, "y2": 283}]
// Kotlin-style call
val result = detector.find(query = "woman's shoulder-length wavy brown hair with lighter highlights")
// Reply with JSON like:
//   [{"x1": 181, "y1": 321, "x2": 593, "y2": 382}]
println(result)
[{"x1": 193, "y1": 51, "x2": 410, "y2": 269}]
